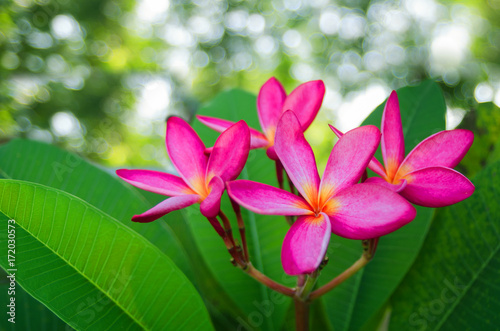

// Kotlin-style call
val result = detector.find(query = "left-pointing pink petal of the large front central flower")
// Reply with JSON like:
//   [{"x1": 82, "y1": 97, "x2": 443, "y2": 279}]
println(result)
[{"x1": 227, "y1": 180, "x2": 312, "y2": 216}]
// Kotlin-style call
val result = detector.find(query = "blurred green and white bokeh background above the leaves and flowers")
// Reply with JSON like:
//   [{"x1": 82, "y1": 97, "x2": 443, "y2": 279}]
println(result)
[{"x1": 0, "y1": 0, "x2": 500, "y2": 173}]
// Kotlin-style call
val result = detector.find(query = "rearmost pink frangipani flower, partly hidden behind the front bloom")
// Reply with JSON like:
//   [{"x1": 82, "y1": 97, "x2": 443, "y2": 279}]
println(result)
[{"x1": 196, "y1": 77, "x2": 325, "y2": 160}]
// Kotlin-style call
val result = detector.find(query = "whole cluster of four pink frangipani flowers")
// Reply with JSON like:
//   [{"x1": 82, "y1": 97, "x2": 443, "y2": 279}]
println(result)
[{"x1": 117, "y1": 78, "x2": 474, "y2": 275}]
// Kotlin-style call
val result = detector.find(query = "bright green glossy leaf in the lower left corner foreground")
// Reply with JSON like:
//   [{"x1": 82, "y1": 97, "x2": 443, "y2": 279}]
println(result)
[{"x1": 0, "y1": 180, "x2": 212, "y2": 330}]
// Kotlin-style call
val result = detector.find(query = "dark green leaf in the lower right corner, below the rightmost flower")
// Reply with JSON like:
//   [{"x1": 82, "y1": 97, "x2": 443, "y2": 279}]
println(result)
[{"x1": 390, "y1": 162, "x2": 500, "y2": 330}]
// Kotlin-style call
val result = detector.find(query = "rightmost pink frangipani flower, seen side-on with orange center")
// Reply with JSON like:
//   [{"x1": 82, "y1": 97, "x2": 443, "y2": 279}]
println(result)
[{"x1": 330, "y1": 91, "x2": 474, "y2": 207}]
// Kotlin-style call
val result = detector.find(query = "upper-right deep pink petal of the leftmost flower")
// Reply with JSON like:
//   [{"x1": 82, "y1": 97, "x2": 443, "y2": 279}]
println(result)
[{"x1": 206, "y1": 121, "x2": 250, "y2": 183}]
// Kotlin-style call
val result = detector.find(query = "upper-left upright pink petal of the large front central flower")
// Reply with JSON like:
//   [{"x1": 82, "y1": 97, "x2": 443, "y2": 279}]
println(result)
[{"x1": 274, "y1": 111, "x2": 320, "y2": 206}]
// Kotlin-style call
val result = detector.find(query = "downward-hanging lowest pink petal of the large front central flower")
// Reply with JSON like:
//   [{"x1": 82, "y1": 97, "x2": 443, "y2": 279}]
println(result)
[{"x1": 281, "y1": 213, "x2": 331, "y2": 276}]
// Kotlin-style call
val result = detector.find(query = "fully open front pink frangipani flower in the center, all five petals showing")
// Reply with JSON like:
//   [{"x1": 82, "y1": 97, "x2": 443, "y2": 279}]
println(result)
[{"x1": 227, "y1": 111, "x2": 416, "y2": 275}]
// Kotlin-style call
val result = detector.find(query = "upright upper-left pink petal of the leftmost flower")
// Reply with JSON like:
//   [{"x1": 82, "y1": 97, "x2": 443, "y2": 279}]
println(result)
[{"x1": 166, "y1": 116, "x2": 208, "y2": 194}]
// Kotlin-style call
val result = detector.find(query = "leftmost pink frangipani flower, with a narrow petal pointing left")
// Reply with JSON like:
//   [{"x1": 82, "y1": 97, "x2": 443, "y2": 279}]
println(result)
[{"x1": 116, "y1": 117, "x2": 250, "y2": 223}]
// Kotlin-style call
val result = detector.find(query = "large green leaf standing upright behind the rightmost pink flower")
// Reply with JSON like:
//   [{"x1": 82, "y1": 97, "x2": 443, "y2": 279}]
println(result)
[{"x1": 319, "y1": 81, "x2": 446, "y2": 330}]
